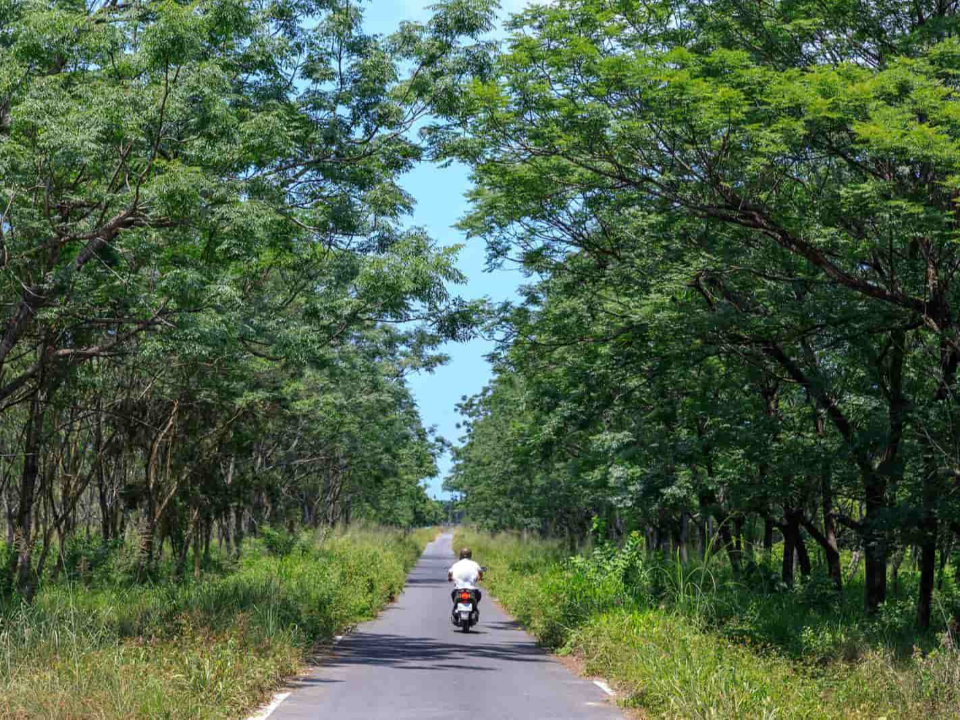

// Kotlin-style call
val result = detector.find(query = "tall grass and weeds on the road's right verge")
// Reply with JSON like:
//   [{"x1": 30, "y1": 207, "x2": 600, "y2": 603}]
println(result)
[{"x1": 455, "y1": 530, "x2": 960, "y2": 720}]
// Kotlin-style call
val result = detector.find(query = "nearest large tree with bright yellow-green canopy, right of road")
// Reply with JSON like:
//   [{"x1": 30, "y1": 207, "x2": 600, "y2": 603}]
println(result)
[{"x1": 435, "y1": 0, "x2": 960, "y2": 626}]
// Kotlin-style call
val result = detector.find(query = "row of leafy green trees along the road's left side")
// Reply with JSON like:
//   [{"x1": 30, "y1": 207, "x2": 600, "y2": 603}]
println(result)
[{"x1": 0, "y1": 0, "x2": 496, "y2": 598}]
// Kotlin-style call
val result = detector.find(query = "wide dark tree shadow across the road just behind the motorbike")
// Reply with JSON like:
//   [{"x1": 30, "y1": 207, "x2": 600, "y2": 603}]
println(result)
[{"x1": 325, "y1": 632, "x2": 547, "y2": 671}]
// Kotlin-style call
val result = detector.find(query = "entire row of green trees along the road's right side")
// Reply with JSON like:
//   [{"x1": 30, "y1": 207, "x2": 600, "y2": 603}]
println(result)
[{"x1": 444, "y1": 0, "x2": 960, "y2": 627}]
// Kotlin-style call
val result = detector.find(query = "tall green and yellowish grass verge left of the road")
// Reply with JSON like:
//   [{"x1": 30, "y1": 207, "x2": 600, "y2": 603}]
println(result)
[{"x1": 0, "y1": 528, "x2": 435, "y2": 720}]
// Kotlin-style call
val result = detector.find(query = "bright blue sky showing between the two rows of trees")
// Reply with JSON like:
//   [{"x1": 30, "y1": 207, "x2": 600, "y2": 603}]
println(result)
[{"x1": 364, "y1": 0, "x2": 525, "y2": 496}]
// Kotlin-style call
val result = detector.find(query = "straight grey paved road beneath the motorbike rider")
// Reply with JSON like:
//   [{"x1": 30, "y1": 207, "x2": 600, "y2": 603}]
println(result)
[{"x1": 270, "y1": 535, "x2": 623, "y2": 720}]
